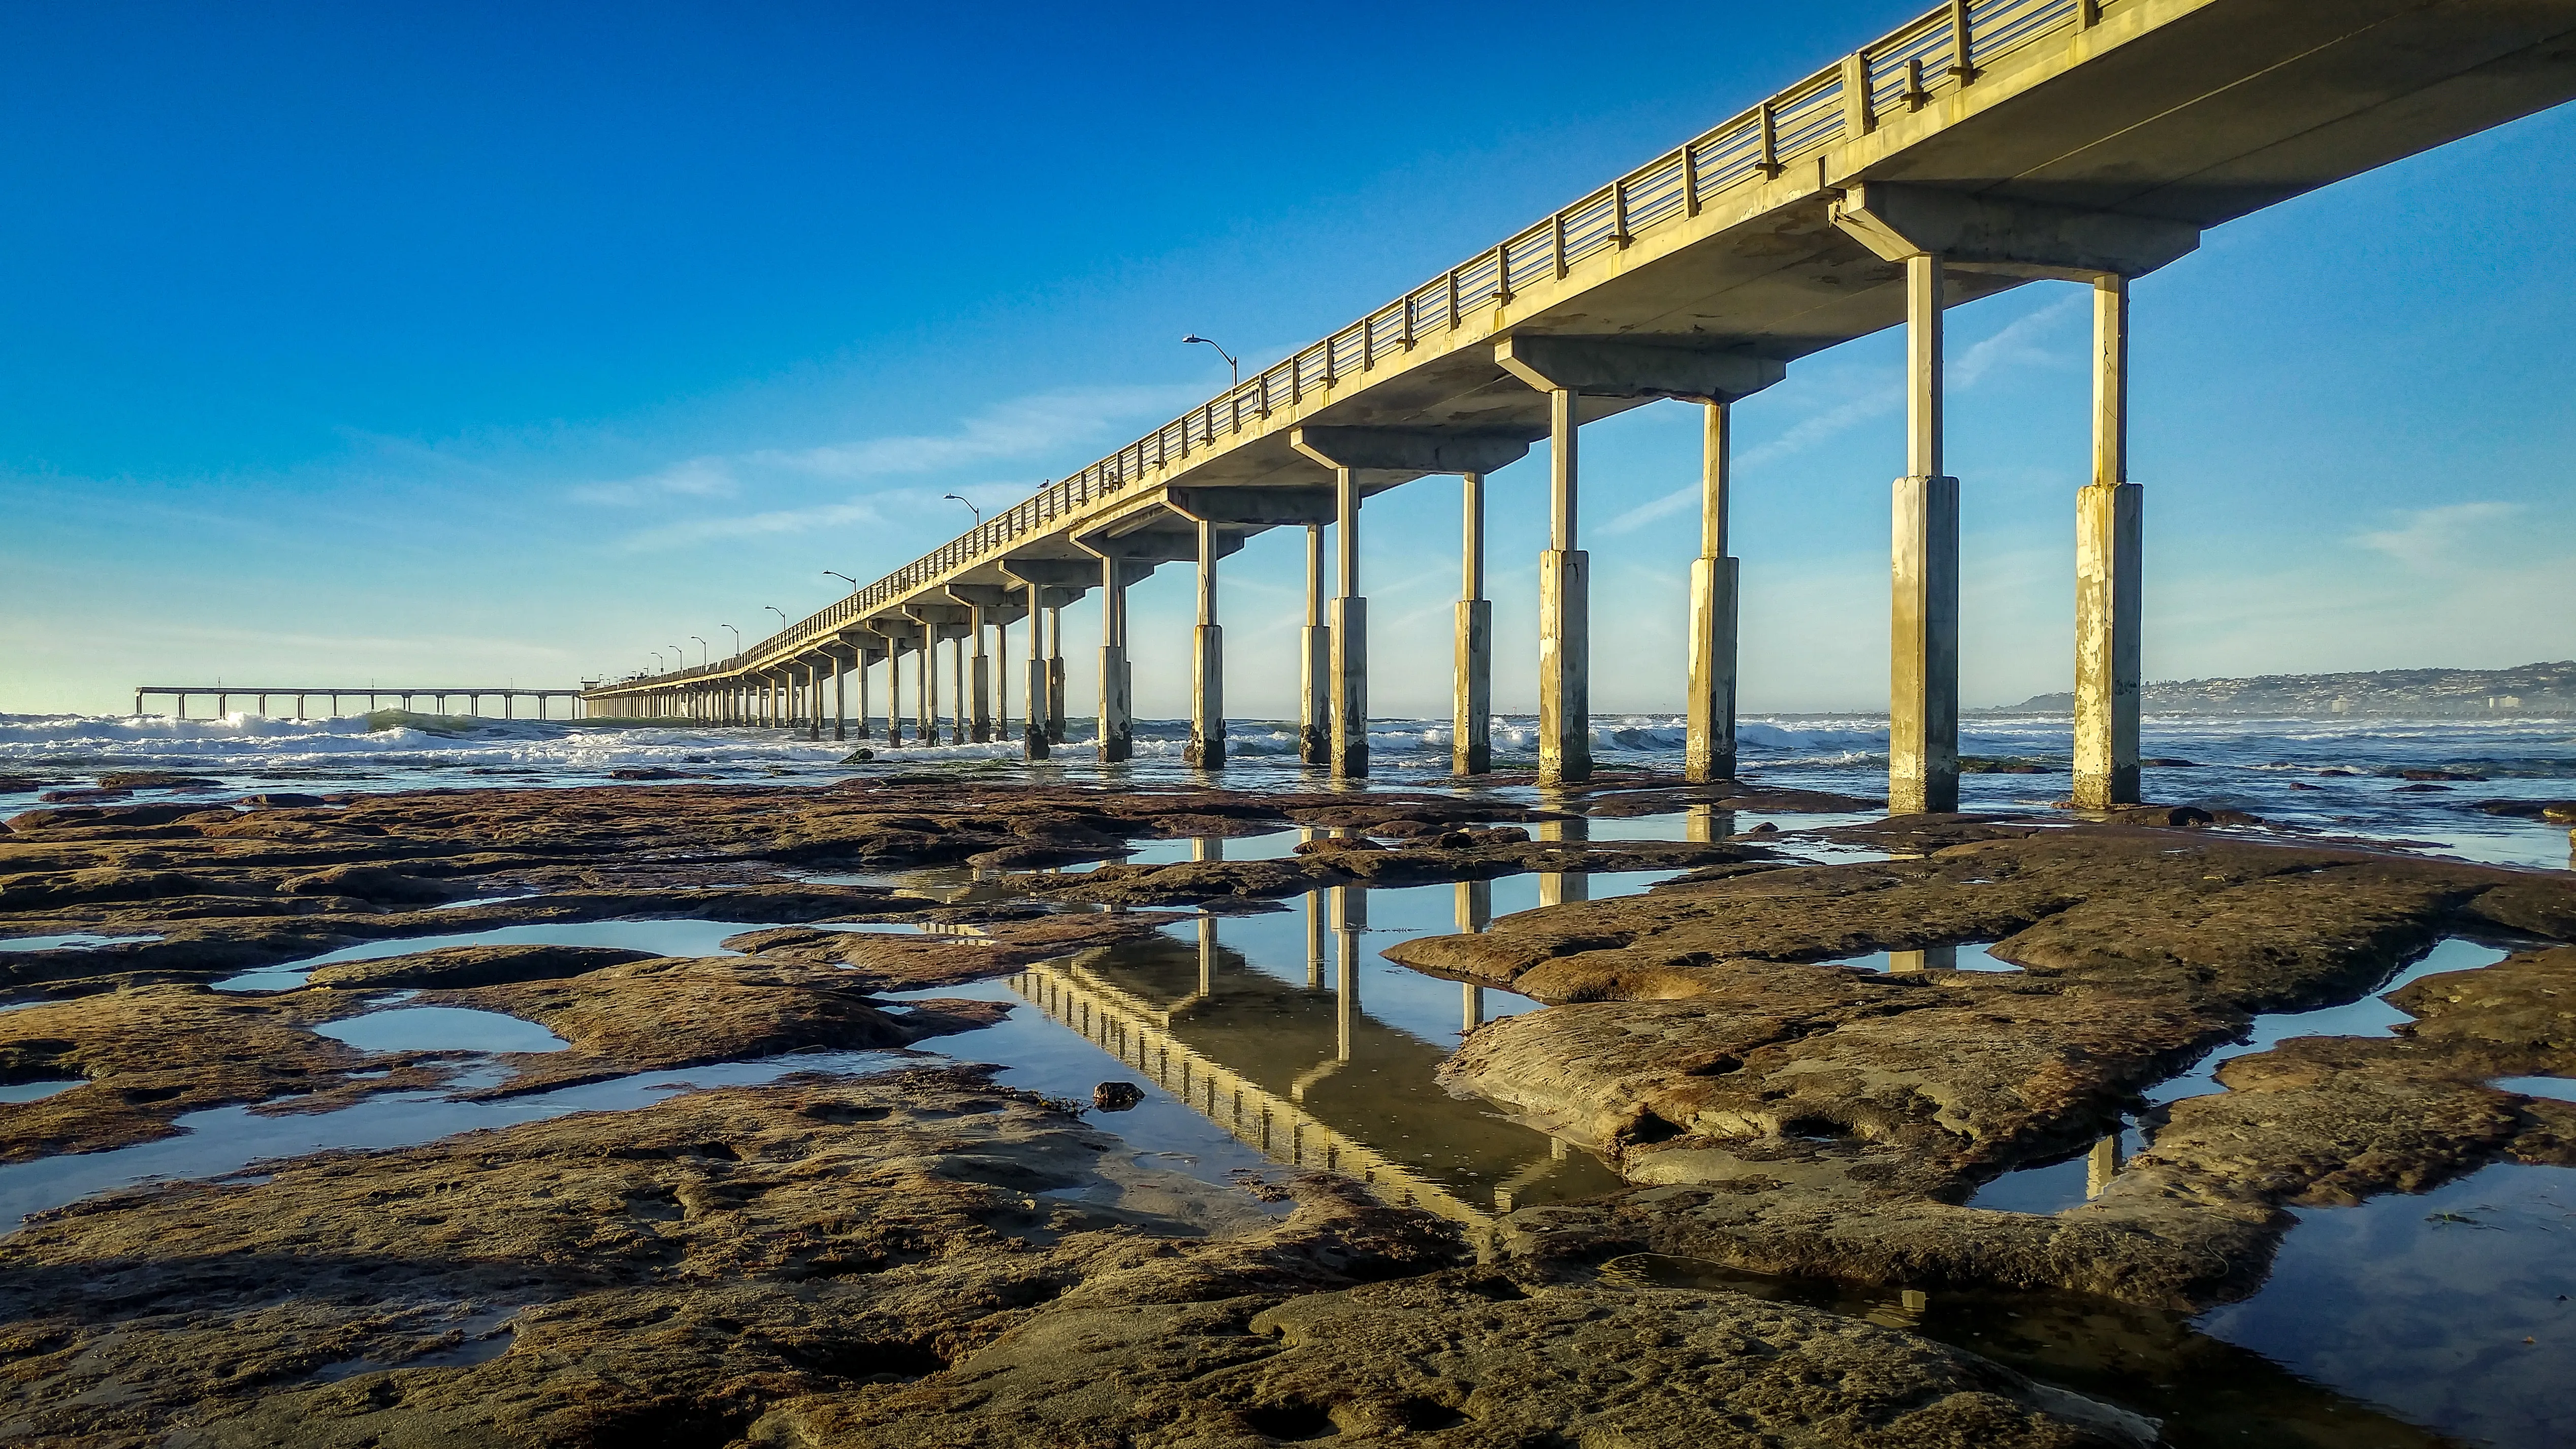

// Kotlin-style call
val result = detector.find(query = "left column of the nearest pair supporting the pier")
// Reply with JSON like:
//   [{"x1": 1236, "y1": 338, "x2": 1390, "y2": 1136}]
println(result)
[{"x1": 1888, "y1": 252, "x2": 1958, "y2": 815}]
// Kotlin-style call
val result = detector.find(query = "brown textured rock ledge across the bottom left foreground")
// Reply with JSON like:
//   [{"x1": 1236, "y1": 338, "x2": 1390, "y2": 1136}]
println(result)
[{"x1": 0, "y1": 1070, "x2": 2151, "y2": 1449}]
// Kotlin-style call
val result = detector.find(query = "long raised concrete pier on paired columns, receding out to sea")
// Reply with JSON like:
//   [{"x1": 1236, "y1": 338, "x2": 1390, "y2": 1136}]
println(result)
[{"x1": 585, "y1": 0, "x2": 2576, "y2": 812}]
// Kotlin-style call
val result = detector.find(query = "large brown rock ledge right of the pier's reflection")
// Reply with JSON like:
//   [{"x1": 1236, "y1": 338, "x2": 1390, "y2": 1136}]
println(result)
[{"x1": 1389, "y1": 817, "x2": 2576, "y2": 1310}]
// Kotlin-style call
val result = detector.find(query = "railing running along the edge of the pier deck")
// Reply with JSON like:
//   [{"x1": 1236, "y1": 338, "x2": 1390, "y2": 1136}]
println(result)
[{"x1": 607, "y1": 0, "x2": 2133, "y2": 688}]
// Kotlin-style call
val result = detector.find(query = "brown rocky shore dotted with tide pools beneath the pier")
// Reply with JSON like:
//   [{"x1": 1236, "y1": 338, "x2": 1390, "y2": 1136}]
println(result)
[{"x1": 0, "y1": 774, "x2": 2576, "y2": 1449}]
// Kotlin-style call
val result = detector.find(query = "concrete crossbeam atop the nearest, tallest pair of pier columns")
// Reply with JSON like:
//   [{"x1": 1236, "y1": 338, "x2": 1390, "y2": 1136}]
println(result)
[{"x1": 1831, "y1": 180, "x2": 2200, "y2": 281}]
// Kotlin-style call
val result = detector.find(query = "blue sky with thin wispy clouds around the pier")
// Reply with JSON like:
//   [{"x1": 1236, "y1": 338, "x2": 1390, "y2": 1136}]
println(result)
[{"x1": 0, "y1": 3, "x2": 2576, "y2": 714}]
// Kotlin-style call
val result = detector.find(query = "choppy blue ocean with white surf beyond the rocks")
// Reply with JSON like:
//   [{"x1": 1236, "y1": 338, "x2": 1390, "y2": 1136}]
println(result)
[{"x1": 0, "y1": 712, "x2": 2576, "y2": 869}]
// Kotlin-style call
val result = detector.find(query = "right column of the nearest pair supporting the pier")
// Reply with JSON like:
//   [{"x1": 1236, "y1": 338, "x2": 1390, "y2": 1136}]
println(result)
[{"x1": 2076, "y1": 276, "x2": 2146, "y2": 810}]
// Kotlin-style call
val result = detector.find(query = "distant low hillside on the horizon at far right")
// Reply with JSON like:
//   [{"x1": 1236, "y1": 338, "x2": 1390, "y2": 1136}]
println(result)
[{"x1": 2007, "y1": 660, "x2": 2576, "y2": 719}]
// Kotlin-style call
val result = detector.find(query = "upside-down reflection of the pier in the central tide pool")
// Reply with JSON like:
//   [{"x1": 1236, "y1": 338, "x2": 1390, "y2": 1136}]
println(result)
[{"x1": 1010, "y1": 874, "x2": 1628, "y2": 1230}]
